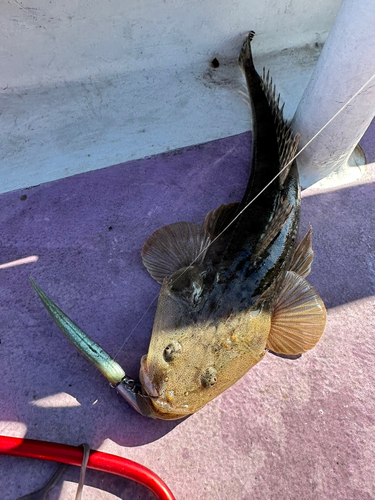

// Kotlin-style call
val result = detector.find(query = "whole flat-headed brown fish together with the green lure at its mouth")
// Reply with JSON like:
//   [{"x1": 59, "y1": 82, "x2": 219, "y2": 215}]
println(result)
[{"x1": 32, "y1": 31, "x2": 326, "y2": 420}]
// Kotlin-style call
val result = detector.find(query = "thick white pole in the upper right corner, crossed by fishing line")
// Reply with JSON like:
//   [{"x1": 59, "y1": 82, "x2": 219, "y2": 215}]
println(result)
[{"x1": 293, "y1": 0, "x2": 375, "y2": 189}]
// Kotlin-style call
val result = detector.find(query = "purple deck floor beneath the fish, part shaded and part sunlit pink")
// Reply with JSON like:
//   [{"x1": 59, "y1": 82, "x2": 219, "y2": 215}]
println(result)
[{"x1": 0, "y1": 125, "x2": 375, "y2": 500}]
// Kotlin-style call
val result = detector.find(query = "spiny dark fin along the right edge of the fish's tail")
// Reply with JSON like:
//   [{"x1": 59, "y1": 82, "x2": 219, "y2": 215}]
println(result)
[{"x1": 261, "y1": 68, "x2": 300, "y2": 185}]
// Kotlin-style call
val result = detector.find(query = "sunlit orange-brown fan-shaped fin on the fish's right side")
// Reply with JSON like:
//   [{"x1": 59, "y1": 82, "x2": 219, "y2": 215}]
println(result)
[{"x1": 267, "y1": 271, "x2": 327, "y2": 355}]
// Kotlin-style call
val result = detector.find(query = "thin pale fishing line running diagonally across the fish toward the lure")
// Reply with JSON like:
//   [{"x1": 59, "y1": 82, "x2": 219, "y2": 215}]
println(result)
[{"x1": 113, "y1": 73, "x2": 375, "y2": 359}]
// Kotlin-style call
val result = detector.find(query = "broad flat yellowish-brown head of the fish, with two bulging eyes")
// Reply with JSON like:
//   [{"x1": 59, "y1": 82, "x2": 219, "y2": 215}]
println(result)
[{"x1": 140, "y1": 268, "x2": 271, "y2": 419}]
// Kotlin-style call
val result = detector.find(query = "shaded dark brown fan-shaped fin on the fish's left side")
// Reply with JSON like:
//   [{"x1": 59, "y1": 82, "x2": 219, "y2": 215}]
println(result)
[{"x1": 142, "y1": 222, "x2": 211, "y2": 283}]
